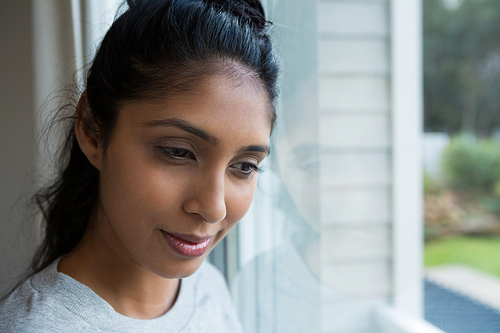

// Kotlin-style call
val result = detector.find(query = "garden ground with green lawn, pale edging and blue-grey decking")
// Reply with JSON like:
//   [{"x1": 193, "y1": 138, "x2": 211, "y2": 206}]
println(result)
[{"x1": 424, "y1": 236, "x2": 500, "y2": 333}]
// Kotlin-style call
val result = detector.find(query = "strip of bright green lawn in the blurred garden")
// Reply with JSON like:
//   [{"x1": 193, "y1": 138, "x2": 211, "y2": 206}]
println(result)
[{"x1": 424, "y1": 236, "x2": 500, "y2": 278}]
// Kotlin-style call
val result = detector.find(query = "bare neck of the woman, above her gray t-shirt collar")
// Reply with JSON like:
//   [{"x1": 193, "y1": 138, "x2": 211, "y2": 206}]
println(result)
[{"x1": 58, "y1": 213, "x2": 180, "y2": 319}]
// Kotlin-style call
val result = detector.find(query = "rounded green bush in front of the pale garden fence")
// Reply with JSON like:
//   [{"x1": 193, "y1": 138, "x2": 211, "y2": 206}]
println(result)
[{"x1": 442, "y1": 135, "x2": 500, "y2": 194}]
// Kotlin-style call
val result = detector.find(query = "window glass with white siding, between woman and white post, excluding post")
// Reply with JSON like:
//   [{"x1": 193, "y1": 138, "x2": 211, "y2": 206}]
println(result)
[{"x1": 230, "y1": 0, "x2": 403, "y2": 333}]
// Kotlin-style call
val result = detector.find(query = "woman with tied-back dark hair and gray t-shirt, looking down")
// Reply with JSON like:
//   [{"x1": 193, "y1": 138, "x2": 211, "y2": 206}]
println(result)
[{"x1": 0, "y1": 0, "x2": 278, "y2": 332}]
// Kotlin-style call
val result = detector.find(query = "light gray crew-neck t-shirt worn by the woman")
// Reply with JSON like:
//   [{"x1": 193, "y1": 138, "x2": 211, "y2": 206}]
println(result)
[{"x1": 0, "y1": 260, "x2": 241, "y2": 333}]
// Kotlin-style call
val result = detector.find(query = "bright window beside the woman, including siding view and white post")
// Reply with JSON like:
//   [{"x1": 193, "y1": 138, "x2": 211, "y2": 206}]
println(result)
[{"x1": 228, "y1": 0, "x2": 439, "y2": 332}]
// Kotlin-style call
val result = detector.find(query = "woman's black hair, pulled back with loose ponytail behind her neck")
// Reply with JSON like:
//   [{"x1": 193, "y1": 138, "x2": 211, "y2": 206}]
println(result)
[{"x1": 31, "y1": 0, "x2": 278, "y2": 273}]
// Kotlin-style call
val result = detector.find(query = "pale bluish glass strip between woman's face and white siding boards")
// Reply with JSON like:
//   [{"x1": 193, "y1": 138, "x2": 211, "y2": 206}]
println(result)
[{"x1": 233, "y1": 0, "x2": 322, "y2": 332}]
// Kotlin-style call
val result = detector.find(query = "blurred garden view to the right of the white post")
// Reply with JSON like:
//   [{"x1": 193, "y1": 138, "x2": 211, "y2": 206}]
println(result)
[{"x1": 423, "y1": 0, "x2": 500, "y2": 332}]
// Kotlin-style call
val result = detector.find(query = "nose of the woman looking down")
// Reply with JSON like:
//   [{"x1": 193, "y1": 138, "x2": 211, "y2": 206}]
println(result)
[{"x1": 184, "y1": 172, "x2": 227, "y2": 224}]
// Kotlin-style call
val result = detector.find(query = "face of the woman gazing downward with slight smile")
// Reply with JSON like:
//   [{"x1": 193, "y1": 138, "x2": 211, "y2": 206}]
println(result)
[{"x1": 95, "y1": 75, "x2": 271, "y2": 278}]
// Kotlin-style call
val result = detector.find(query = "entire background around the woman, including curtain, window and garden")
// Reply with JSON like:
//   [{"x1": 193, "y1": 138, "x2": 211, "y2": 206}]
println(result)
[{"x1": 0, "y1": 0, "x2": 500, "y2": 333}]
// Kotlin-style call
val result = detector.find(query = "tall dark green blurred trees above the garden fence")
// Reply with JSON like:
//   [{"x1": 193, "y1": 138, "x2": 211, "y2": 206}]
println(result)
[{"x1": 423, "y1": 0, "x2": 500, "y2": 136}]
